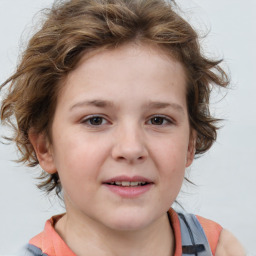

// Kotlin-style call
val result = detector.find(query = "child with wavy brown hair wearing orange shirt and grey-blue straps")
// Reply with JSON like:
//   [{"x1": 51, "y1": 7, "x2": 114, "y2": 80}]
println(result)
[{"x1": 1, "y1": 0, "x2": 245, "y2": 256}]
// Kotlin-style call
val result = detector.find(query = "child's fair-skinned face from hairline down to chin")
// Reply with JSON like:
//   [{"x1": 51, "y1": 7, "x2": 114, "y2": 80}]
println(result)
[{"x1": 39, "y1": 44, "x2": 194, "y2": 230}]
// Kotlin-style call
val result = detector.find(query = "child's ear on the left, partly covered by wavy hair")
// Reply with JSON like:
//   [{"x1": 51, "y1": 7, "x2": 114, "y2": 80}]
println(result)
[{"x1": 29, "y1": 132, "x2": 57, "y2": 174}]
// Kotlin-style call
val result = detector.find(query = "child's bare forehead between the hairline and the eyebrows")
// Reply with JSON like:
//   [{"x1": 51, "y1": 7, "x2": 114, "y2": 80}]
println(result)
[{"x1": 59, "y1": 43, "x2": 186, "y2": 109}]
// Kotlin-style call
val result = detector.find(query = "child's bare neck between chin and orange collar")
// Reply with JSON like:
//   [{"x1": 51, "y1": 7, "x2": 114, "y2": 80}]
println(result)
[{"x1": 55, "y1": 210, "x2": 174, "y2": 256}]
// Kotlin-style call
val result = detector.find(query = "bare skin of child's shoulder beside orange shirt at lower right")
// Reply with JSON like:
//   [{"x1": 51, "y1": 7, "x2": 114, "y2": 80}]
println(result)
[{"x1": 215, "y1": 229, "x2": 246, "y2": 256}]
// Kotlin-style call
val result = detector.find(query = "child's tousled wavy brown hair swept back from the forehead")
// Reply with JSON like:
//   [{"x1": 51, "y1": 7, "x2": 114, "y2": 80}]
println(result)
[{"x1": 1, "y1": 0, "x2": 228, "y2": 194}]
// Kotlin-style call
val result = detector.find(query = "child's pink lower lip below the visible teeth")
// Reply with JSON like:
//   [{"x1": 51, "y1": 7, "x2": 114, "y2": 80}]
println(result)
[{"x1": 104, "y1": 184, "x2": 153, "y2": 198}]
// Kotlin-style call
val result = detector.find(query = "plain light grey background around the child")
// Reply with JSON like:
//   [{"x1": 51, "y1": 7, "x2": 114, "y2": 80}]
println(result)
[{"x1": 0, "y1": 0, "x2": 256, "y2": 255}]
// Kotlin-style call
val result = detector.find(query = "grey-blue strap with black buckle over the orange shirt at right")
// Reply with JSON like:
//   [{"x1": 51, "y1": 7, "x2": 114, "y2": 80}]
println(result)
[{"x1": 178, "y1": 213, "x2": 213, "y2": 256}]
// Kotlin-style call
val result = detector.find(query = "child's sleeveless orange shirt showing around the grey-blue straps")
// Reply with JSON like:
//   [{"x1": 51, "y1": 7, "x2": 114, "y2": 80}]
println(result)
[{"x1": 29, "y1": 209, "x2": 222, "y2": 256}]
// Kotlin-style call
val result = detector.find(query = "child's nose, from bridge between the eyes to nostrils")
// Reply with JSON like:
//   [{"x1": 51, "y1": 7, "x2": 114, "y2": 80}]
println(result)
[{"x1": 112, "y1": 122, "x2": 148, "y2": 164}]
